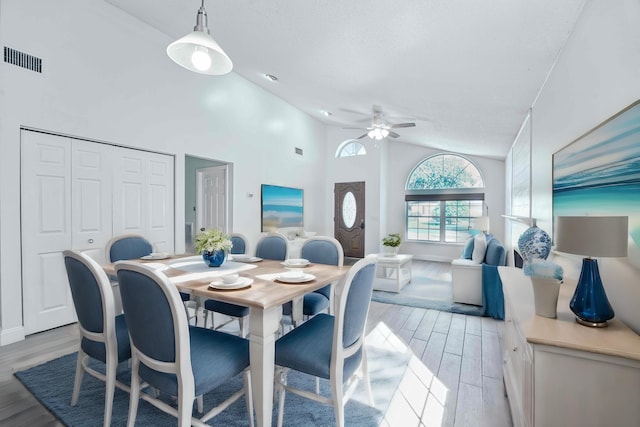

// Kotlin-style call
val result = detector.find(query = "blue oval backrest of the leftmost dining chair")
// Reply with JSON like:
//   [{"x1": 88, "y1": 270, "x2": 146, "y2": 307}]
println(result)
[{"x1": 62, "y1": 250, "x2": 117, "y2": 362}]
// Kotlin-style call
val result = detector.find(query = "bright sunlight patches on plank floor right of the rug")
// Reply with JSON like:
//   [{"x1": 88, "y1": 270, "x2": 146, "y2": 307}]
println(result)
[{"x1": 367, "y1": 322, "x2": 449, "y2": 427}]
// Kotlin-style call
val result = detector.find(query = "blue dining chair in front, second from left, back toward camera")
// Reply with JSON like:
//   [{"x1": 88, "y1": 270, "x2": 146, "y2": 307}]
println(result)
[{"x1": 115, "y1": 261, "x2": 253, "y2": 427}]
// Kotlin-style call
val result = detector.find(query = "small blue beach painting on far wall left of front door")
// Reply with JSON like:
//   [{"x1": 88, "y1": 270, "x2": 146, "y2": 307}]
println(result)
[{"x1": 262, "y1": 184, "x2": 304, "y2": 231}]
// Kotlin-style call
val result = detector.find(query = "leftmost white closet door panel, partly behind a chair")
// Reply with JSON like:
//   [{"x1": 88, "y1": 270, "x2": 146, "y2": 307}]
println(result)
[{"x1": 21, "y1": 131, "x2": 75, "y2": 335}]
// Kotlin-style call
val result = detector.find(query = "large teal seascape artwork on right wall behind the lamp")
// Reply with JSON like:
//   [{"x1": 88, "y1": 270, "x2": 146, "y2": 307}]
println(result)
[{"x1": 553, "y1": 101, "x2": 640, "y2": 266}]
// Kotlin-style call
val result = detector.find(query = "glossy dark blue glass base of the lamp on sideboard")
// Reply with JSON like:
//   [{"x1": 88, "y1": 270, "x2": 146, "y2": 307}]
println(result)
[{"x1": 569, "y1": 258, "x2": 614, "y2": 328}]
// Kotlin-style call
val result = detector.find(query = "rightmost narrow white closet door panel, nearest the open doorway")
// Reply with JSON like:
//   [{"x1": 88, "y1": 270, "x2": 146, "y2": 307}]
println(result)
[{"x1": 146, "y1": 153, "x2": 175, "y2": 253}]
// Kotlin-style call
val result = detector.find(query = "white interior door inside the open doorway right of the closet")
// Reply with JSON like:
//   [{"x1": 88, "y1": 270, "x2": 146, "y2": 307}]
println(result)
[{"x1": 196, "y1": 166, "x2": 229, "y2": 233}]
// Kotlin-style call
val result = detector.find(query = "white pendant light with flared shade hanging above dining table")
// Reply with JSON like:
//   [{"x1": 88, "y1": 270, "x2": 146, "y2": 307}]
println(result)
[{"x1": 167, "y1": 0, "x2": 233, "y2": 76}]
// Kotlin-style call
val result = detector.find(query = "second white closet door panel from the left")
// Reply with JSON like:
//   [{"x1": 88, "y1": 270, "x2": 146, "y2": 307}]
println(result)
[{"x1": 71, "y1": 139, "x2": 113, "y2": 264}]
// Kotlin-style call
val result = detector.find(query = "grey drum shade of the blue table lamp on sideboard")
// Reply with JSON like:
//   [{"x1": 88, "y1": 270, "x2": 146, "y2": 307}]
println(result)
[{"x1": 554, "y1": 216, "x2": 629, "y2": 257}]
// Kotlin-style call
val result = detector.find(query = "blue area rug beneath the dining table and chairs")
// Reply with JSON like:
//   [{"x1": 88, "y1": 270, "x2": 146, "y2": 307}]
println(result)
[{"x1": 15, "y1": 331, "x2": 411, "y2": 427}]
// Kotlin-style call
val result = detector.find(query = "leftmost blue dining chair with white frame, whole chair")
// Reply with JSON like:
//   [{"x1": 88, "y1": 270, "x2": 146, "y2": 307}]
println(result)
[{"x1": 63, "y1": 250, "x2": 131, "y2": 426}]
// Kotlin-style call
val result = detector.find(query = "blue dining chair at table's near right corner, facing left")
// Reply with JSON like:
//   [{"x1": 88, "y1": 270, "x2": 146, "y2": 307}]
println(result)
[{"x1": 275, "y1": 257, "x2": 376, "y2": 427}]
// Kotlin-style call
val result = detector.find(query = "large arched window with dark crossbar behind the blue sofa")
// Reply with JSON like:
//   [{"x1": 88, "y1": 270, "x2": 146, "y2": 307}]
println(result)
[{"x1": 405, "y1": 154, "x2": 484, "y2": 243}]
